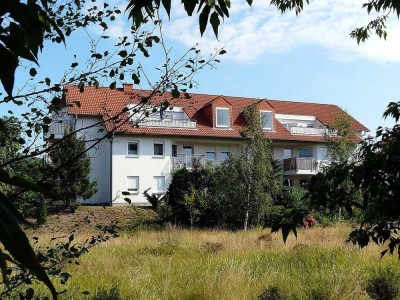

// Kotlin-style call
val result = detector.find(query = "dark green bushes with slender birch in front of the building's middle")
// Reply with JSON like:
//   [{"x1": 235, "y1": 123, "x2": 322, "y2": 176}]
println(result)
[{"x1": 158, "y1": 106, "x2": 282, "y2": 230}]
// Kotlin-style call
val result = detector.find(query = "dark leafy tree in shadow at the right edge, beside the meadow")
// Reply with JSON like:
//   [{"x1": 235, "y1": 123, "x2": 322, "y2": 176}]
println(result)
[{"x1": 312, "y1": 102, "x2": 400, "y2": 256}]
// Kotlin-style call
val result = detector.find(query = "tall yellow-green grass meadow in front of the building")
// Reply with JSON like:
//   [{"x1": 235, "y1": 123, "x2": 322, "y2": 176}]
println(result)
[{"x1": 21, "y1": 209, "x2": 400, "y2": 299}]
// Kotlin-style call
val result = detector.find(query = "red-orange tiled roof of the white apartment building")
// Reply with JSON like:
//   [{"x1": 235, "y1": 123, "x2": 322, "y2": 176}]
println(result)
[{"x1": 64, "y1": 85, "x2": 368, "y2": 142}]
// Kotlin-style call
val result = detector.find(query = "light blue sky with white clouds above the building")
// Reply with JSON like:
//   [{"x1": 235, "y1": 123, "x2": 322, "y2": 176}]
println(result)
[{"x1": 0, "y1": 0, "x2": 400, "y2": 132}]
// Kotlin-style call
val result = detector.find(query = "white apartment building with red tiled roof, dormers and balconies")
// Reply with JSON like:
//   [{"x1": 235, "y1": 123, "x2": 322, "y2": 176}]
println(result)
[{"x1": 47, "y1": 85, "x2": 368, "y2": 205}]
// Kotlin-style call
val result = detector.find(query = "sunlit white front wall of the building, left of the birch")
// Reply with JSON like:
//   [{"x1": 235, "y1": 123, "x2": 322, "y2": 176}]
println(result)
[{"x1": 112, "y1": 135, "x2": 240, "y2": 205}]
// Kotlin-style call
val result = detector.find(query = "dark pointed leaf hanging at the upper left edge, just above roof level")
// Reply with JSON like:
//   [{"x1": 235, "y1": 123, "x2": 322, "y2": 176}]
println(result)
[{"x1": 0, "y1": 44, "x2": 18, "y2": 97}]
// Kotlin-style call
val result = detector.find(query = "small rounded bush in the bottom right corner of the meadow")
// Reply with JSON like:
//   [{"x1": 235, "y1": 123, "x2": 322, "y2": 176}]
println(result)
[{"x1": 366, "y1": 268, "x2": 400, "y2": 300}]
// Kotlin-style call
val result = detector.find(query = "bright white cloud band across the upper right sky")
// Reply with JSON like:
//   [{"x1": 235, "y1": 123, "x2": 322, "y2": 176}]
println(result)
[{"x1": 164, "y1": 0, "x2": 400, "y2": 63}]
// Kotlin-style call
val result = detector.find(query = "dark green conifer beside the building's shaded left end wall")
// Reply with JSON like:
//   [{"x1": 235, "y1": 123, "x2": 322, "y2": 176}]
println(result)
[{"x1": 46, "y1": 134, "x2": 97, "y2": 211}]
